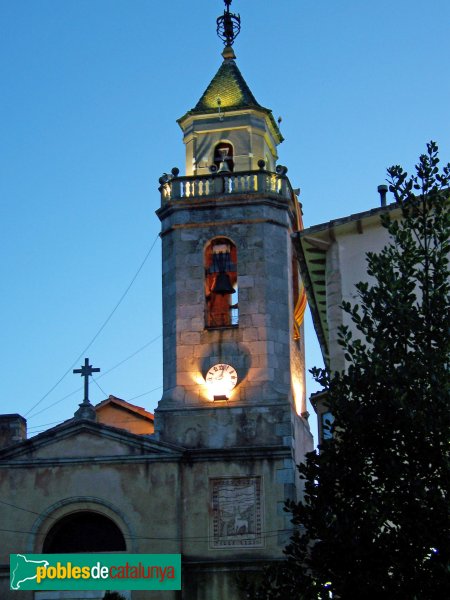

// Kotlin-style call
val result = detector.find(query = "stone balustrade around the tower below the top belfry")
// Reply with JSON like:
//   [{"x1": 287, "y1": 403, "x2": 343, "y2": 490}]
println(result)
[{"x1": 159, "y1": 168, "x2": 293, "y2": 205}]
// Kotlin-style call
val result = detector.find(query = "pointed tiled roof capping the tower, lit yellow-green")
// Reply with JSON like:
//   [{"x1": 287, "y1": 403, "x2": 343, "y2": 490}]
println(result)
[{"x1": 178, "y1": 58, "x2": 283, "y2": 141}]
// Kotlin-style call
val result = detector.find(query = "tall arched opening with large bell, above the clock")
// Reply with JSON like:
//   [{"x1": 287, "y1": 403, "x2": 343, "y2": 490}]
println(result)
[{"x1": 205, "y1": 238, "x2": 239, "y2": 328}]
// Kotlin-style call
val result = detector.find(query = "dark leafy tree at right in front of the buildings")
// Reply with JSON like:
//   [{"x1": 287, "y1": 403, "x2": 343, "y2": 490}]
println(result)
[{"x1": 248, "y1": 142, "x2": 450, "y2": 600}]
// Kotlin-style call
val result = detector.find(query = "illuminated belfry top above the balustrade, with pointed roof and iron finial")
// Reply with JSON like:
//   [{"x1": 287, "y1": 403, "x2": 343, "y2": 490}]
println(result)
[{"x1": 175, "y1": 0, "x2": 283, "y2": 177}]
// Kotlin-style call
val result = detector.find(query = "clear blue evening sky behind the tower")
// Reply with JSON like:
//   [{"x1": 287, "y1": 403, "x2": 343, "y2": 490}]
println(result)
[{"x1": 0, "y1": 0, "x2": 450, "y2": 434}]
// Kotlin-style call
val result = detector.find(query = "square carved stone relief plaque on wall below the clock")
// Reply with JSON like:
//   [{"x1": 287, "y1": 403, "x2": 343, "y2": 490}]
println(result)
[{"x1": 210, "y1": 477, "x2": 263, "y2": 548}]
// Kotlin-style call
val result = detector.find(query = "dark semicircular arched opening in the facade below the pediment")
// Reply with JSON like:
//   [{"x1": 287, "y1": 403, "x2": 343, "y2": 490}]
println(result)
[{"x1": 42, "y1": 511, "x2": 127, "y2": 554}]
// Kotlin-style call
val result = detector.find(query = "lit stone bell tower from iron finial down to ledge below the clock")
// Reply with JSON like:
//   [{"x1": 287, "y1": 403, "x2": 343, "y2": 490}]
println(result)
[{"x1": 156, "y1": 0, "x2": 312, "y2": 462}]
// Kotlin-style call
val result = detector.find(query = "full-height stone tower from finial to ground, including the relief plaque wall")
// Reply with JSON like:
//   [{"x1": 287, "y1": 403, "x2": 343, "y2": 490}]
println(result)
[{"x1": 155, "y1": 7, "x2": 312, "y2": 600}]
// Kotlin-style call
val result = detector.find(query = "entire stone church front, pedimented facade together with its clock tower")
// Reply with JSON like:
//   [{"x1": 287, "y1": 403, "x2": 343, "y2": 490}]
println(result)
[{"x1": 0, "y1": 3, "x2": 313, "y2": 600}]
